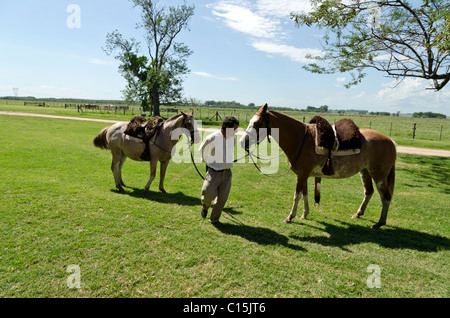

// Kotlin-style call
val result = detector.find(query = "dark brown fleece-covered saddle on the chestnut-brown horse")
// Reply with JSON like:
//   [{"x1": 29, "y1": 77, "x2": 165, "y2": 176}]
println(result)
[{"x1": 310, "y1": 116, "x2": 361, "y2": 175}]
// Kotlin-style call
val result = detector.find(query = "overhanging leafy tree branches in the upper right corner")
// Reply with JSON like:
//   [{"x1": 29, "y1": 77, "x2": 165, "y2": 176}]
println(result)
[{"x1": 291, "y1": 0, "x2": 450, "y2": 91}]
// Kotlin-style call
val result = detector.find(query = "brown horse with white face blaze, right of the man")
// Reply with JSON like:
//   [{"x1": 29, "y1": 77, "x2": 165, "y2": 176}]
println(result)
[{"x1": 240, "y1": 104, "x2": 396, "y2": 228}]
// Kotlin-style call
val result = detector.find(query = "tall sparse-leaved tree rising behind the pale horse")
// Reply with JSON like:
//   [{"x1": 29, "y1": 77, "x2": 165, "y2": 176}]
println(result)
[{"x1": 103, "y1": 0, "x2": 195, "y2": 116}]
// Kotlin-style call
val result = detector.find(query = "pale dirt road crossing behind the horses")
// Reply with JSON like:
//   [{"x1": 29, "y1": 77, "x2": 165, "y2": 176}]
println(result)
[{"x1": 0, "y1": 111, "x2": 450, "y2": 157}]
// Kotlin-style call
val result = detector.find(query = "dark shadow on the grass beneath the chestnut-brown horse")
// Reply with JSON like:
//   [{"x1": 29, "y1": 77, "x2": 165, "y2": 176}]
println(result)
[{"x1": 291, "y1": 222, "x2": 450, "y2": 252}]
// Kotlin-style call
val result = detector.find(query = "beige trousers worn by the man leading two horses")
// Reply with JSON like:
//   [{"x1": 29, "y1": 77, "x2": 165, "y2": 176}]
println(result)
[{"x1": 202, "y1": 168, "x2": 232, "y2": 223}]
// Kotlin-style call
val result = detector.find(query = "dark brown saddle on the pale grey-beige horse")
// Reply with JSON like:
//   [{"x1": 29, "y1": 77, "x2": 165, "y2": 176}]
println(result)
[{"x1": 124, "y1": 116, "x2": 164, "y2": 161}]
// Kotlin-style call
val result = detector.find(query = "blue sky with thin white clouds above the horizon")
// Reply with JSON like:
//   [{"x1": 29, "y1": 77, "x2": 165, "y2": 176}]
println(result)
[{"x1": 0, "y1": 0, "x2": 450, "y2": 115}]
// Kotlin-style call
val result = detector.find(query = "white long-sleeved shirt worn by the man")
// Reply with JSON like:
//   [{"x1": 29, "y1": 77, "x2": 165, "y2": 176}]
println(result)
[{"x1": 198, "y1": 130, "x2": 236, "y2": 170}]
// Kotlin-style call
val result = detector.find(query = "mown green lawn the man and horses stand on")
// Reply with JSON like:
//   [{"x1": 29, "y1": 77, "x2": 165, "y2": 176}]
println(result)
[{"x1": 0, "y1": 112, "x2": 450, "y2": 298}]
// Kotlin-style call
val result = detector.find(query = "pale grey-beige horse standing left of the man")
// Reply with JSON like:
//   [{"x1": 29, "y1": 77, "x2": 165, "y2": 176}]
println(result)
[{"x1": 93, "y1": 111, "x2": 201, "y2": 194}]
